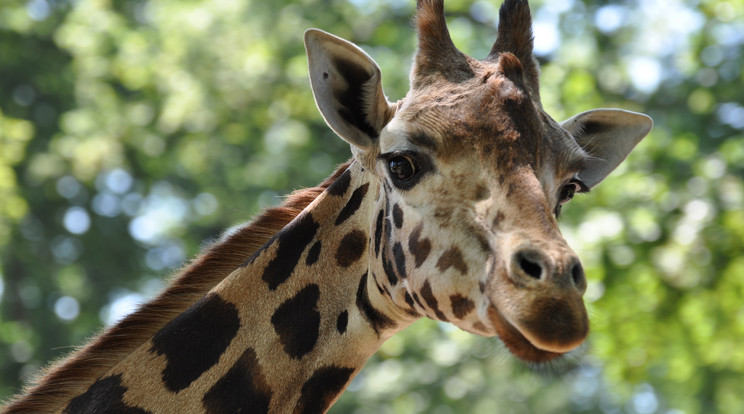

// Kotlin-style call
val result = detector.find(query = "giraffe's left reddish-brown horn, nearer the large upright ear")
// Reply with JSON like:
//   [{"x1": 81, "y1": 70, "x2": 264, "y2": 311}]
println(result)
[{"x1": 411, "y1": 0, "x2": 474, "y2": 88}]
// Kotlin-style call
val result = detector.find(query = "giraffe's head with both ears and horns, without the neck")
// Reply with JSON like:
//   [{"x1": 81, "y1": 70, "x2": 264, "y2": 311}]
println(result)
[{"x1": 305, "y1": 0, "x2": 652, "y2": 361}]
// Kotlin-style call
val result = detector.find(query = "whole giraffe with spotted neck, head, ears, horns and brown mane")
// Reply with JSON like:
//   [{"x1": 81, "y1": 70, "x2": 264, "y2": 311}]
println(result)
[{"x1": 4, "y1": 0, "x2": 652, "y2": 413}]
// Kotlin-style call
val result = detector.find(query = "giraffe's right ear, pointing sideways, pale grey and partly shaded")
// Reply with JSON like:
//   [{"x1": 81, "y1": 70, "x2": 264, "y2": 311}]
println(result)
[{"x1": 561, "y1": 109, "x2": 654, "y2": 188}]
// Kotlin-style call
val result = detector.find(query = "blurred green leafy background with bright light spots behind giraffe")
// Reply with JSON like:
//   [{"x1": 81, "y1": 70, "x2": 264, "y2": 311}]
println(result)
[{"x1": 0, "y1": 0, "x2": 744, "y2": 414}]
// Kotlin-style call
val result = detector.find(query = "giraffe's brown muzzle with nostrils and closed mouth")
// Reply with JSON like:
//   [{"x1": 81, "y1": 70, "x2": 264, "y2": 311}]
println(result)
[{"x1": 489, "y1": 242, "x2": 589, "y2": 362}]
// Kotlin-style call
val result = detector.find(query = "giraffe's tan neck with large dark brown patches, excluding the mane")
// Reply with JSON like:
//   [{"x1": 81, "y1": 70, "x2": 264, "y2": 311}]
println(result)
[{"x1": 60, "y1": 162, "x2": 415, "y2": 413}]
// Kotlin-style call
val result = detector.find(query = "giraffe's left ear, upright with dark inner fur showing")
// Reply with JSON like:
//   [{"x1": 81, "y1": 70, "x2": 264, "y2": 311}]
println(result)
[{"x1": 305, "y1": 29, "x2": 395, "y2": 150}]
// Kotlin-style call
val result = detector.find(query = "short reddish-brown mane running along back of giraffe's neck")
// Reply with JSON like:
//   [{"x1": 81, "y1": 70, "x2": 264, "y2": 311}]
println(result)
[{"x1": 3, "y1": 163, "x2": 349, "y2": 413}]
